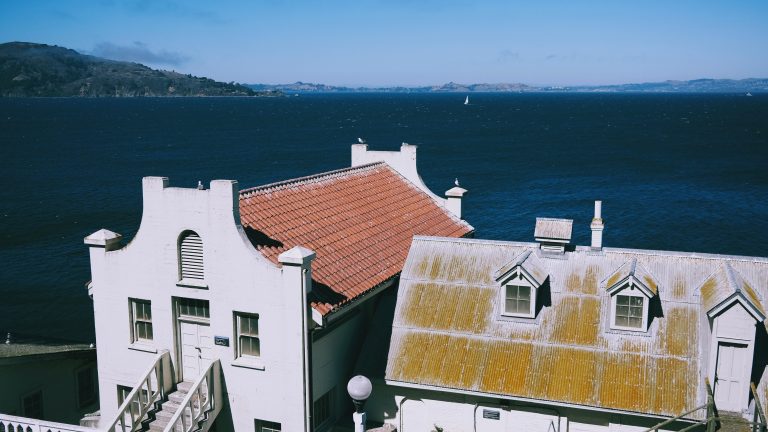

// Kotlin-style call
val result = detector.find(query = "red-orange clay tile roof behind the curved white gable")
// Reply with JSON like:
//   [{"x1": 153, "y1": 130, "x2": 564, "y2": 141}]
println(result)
[{"x1": 240, "y1": 162, "x2": 473, "y2": 315}]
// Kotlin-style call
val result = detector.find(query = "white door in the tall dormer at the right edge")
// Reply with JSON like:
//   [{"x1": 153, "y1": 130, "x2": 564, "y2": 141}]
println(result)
[{"x1": 714, "y1": 342, "x2": 748, "y2": 411}]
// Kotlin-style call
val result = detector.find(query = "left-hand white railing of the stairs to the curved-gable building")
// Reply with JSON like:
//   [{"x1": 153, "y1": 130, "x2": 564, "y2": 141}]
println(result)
[{"x1": 106, "y1": 351, "x2": 173, "y2": 432}]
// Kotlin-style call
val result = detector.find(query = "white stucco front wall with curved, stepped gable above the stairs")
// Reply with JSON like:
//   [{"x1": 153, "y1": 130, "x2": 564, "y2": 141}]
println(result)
[{"x1": 91, "y1": 177, "x2": 311, "y2": 431}]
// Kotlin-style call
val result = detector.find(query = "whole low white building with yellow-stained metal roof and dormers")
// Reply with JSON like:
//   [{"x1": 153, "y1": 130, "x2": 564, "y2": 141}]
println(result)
[{"x1": 370, "y1": 203, "x2": 768, "y2": 432}]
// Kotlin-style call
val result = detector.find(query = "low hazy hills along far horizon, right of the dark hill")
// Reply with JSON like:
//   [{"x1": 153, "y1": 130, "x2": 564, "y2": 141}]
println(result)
[{"x1": 246, "y1": 78, "x2": 768, "y2": 93}]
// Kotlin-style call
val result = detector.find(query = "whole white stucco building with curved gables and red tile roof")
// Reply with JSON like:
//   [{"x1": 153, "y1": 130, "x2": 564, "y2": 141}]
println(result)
[{"x1": 85, "y1": 145, "x2": 472, "y2": 431}]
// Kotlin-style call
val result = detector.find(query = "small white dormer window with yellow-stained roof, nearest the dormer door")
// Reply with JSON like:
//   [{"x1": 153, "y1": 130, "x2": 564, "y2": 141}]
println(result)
[{"x1": 605, "y1": 258, "x2": 658, "y2": 332}]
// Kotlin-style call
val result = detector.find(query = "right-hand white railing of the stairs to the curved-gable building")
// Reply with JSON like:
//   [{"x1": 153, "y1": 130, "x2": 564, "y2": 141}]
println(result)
[{"x1": 163, "y1": 360, "x2": 223, "y2": 432}]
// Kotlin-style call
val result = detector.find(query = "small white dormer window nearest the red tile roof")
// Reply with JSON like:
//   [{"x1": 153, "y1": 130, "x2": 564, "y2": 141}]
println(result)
[{"x1": 494, "y1": 251, "x2": 549, "y2": 318}]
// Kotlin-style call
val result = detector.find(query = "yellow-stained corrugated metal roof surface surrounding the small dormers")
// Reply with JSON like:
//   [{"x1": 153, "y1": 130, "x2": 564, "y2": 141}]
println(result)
[{"x1": 385, "y1": 237, "x2": 768, "y2": 418}]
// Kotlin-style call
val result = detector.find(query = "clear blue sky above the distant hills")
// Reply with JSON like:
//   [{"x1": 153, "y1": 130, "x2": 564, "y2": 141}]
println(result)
[{"x1": 0, "y1": 0, "x2": 768, "y2": 86}]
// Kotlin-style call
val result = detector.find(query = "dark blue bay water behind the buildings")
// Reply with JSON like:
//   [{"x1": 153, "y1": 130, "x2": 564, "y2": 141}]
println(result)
[{"x1": 0, "y1": 94, "x2": 768, "y2": 340}]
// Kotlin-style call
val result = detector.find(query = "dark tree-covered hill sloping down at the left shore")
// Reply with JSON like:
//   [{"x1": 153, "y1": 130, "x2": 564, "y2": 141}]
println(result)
[{"x1": 0, "y1": 42, "x2": 275, "y2": 97}]
